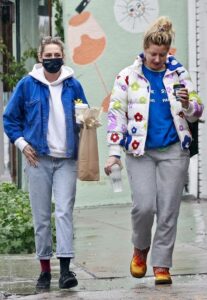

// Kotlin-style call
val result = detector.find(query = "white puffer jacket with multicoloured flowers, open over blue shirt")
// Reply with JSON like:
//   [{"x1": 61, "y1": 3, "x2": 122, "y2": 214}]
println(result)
[{"x1": 107, "y1": 54, "x2": 203, "y2": 156}]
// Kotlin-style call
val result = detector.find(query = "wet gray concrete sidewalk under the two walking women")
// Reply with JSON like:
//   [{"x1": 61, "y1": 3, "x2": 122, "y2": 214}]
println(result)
[{"x1": 0, "y1": 199, "x2": 207, "y2": 300}]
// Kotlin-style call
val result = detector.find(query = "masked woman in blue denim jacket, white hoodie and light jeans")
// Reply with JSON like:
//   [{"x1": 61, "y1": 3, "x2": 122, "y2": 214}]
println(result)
[{"x1": 4, "y1": 37, "x2": 87, "y2": 289}]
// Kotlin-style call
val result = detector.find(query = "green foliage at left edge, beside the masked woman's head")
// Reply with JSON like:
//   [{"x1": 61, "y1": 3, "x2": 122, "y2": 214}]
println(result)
[{"x1": 0, "y1": 40, "x2": 37, "y2": 91}]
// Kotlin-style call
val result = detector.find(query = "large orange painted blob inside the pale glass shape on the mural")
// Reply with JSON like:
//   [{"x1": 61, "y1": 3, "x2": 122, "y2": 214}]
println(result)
[{"x1": 73, "y1": 34, "x2": 106, "y2": 65}]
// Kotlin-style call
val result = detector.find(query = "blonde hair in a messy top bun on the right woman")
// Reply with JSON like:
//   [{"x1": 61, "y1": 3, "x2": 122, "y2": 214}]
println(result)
[{"x1": 143, "y1": 16, "x2": 175, "y2": 49}]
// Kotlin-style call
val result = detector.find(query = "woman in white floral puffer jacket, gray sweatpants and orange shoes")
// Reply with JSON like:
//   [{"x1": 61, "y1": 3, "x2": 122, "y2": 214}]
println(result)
[{"x1": 105, "y1": 17, "x2": 203, "y2": 284}]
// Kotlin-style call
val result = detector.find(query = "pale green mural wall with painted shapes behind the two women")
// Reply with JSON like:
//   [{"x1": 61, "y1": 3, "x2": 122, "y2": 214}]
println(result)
[{"x1": 63, "y1": 0, "x2": 188, "y2": 206}]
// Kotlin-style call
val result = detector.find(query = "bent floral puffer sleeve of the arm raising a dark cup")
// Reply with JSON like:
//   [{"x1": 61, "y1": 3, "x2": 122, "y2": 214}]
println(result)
[{"x1": 178, "y1": 67, "x2": 204, "y2": 123}]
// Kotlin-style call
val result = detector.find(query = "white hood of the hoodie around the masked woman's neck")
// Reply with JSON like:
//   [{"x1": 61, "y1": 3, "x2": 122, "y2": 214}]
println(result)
[{"x1": 29, "y1": 63, "x2": 74, "y2": 85}]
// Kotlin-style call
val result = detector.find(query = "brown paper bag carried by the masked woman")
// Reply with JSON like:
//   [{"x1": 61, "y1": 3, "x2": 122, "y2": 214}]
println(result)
[{"x1": 78, "y1": 124, "x2": 100, "y2": 181}]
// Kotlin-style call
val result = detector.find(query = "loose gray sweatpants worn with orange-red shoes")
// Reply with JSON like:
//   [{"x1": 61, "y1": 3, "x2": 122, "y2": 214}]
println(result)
[{"x1": 126, "y1": 143, "x2": 189, "y2": 268}]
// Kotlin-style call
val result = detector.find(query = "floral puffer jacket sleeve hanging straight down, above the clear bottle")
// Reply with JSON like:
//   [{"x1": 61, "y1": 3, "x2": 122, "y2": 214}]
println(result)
[{"x1": 107, "y1": 69, "x2": 128, "y2": 156}]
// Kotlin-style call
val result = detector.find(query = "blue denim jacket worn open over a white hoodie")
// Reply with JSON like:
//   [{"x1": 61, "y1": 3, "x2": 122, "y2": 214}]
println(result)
[{"x1": 3, "y1": 75, "x2": 87, "y2": 159}]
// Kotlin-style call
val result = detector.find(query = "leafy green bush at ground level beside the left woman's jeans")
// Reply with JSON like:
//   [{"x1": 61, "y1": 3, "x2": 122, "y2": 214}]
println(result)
[{"x1": 0, "y1": 183, "x2": 55, "y2": 254}]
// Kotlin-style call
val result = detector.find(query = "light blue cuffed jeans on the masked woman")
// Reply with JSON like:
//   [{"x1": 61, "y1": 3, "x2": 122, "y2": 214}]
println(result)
[{"x1": 26, "y1": 156, "x2": 77, "y2": 259}]
